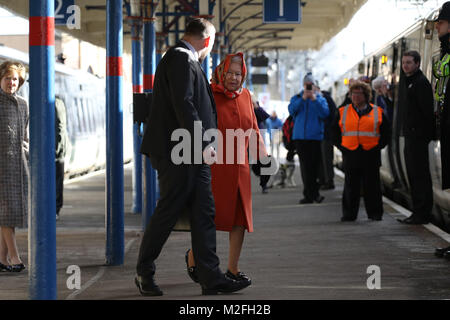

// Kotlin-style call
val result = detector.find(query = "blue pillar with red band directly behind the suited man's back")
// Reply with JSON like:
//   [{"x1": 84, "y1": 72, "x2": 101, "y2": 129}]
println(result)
[{"x1": 142, "y1": 15, "x2": 157, "y2": 230}]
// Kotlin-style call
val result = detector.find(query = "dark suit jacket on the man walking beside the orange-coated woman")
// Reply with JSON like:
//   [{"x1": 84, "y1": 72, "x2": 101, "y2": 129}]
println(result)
[{"x1": 141, "y1": 41, "x2": 217, "y2": 169}]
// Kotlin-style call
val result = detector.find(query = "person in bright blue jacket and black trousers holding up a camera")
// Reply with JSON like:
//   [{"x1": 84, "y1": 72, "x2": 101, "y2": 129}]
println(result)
[{"x1": 288, "y1": 73, "x2": 329, "y2": 204}]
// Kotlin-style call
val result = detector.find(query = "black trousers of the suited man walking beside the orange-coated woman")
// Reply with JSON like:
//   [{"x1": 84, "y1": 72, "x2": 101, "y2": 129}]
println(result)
[{"x1": 136, "y1": 160, "x2": 222, "y2": 286}]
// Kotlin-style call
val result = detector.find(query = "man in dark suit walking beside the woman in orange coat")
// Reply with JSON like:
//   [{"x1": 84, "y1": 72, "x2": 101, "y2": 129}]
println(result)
[{"x1": 135, "y1": 19, "x2": 248, "y2": 296}]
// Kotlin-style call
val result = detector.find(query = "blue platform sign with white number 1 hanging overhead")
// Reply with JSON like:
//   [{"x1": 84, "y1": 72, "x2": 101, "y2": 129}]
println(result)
[{"x1": 263, "y1": 0, "x2": 302, "y2": 23}]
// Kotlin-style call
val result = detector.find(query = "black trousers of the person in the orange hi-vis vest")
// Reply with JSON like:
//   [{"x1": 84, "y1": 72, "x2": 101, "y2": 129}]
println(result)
[{"x1": 342, "y1": 165, "x2": 383, "y2": 220}]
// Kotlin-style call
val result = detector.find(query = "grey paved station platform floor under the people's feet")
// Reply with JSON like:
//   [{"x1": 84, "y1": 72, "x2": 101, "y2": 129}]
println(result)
[{"x1": 0, "y1": 166, "x2": 450, "y2": 300}]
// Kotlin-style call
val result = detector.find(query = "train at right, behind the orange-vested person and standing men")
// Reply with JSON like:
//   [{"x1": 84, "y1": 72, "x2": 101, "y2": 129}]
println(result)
[{"x1": 334, "y1": 10, "x2": 450, "y2": 232}]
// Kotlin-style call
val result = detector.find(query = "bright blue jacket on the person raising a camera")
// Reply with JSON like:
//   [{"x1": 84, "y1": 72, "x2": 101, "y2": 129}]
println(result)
[{"x1": 288, "y1": 90, "x2": 330, "y2": 140}]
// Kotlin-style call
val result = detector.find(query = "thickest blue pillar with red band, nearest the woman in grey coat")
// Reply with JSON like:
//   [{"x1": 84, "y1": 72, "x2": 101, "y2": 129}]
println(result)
[{"x1": 28, "y1": 0, "x2": 57, "y2": 300}]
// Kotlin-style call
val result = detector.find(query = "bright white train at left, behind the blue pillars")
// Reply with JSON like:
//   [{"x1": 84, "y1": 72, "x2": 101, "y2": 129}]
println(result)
[{"x1": 0, "y1": 46, "x2": 133, "y2": 177}]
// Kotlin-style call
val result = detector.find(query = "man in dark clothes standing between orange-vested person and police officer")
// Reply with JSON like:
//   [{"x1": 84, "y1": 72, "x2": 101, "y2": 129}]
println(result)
[{"x1": 399, "y1": 50, "x2": 434, "y2": 224}]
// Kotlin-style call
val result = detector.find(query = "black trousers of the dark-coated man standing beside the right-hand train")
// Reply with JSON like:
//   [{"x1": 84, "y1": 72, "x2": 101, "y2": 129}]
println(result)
[{"x1": 403, "y1": 137, "x2": 433, "y2": 218}]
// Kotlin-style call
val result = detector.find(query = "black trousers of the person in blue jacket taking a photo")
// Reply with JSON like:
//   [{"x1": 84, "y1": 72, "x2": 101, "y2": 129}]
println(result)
[{"x1": 294, "y1": 140, "x2": 322, "y2": 201}]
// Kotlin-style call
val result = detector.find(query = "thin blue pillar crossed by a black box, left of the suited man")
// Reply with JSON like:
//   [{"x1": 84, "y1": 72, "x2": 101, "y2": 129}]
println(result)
[{"x1": 131, "y1": 20, "x2": 143, "y2": 213}]
